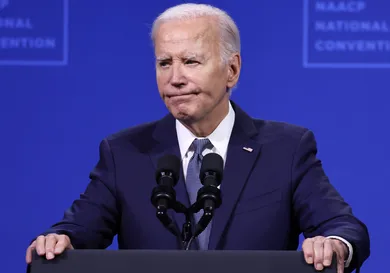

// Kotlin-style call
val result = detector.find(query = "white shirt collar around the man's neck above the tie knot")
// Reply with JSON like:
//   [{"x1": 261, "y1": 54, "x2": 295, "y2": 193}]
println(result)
[{"x1": 176, "y1": 102, "x2": 235, "y2": 159}]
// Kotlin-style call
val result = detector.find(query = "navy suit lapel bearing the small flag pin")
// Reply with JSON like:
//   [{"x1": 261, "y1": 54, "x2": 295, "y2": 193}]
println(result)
[{"x1": 209, "y1": 103, "x2": 261, "y2": 249}]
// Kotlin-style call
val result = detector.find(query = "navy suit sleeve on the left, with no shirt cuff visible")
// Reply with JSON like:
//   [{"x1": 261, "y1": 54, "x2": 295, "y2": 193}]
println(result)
[{"x1": 39, "y1": 140, "x2": 119, "y2": 249}]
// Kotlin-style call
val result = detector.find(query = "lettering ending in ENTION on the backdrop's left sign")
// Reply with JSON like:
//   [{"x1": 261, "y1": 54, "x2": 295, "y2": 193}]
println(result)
[{"x1": 0, "y1": 37, "x2": 56, "y2": 49}]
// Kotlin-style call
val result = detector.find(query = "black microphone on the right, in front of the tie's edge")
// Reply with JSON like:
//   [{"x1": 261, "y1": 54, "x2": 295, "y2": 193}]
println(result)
[{"x1": 194, "y1": 153, "x2": 223, "y2": 237}]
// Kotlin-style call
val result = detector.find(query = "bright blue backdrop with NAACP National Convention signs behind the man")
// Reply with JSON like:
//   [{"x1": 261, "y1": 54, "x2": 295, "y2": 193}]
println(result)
[{"x1": 0, "y1": 0, "x2": 390, "y2": 273}]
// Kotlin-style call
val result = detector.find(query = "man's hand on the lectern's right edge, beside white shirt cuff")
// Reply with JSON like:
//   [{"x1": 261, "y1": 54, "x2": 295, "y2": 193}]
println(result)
[{"x1": 302, "y1": 236, "x2": 348, "y2": 273}]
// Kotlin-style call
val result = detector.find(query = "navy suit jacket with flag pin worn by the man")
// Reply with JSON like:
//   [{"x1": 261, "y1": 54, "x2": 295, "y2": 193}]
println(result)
[{"x1": 44, "y1": 102, "x2": 370, "y2": 269}]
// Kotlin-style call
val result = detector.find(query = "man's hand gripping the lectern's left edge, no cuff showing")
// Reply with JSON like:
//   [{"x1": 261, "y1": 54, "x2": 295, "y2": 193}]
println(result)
[{"x1": 26, "y1": 233, "x2": 73, "y2": 264}]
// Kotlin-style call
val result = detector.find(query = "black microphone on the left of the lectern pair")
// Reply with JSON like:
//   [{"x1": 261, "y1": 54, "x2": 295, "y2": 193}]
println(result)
[{"x1": 151, "y1": 155, "x2": 180, "y2": 236}]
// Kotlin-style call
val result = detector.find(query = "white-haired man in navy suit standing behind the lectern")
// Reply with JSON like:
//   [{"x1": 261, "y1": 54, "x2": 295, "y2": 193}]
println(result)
[{"x1": 26, "y1": 4, "x2": 370, "y2": 272}]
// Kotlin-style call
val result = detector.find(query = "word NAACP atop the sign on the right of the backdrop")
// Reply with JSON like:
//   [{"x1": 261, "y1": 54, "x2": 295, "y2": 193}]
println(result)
[{"x1": 315, "y1": 1, "x2": 366, "y2": 13}]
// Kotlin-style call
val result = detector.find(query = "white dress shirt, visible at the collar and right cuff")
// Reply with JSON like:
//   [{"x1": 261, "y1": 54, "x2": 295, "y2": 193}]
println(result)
[{"x1": 176, "y1": 103, "x2": 353, "y2": 267}]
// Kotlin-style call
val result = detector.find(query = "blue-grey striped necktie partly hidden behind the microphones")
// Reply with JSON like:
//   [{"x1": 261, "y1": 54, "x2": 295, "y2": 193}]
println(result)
[{"x1": 186, "y1": 138, "x2": 213, "y2": 250}]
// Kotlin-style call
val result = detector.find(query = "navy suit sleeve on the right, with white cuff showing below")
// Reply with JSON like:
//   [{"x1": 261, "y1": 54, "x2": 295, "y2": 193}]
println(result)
[{"x1": 292, "y1": 131, "x2": 370, "y2": 272}]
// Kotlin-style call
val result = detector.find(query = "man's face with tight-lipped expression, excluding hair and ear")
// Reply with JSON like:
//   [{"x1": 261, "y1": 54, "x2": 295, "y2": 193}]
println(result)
[{"x1": 155, "y1": 18, "x2": 229, "y2": 122}]
